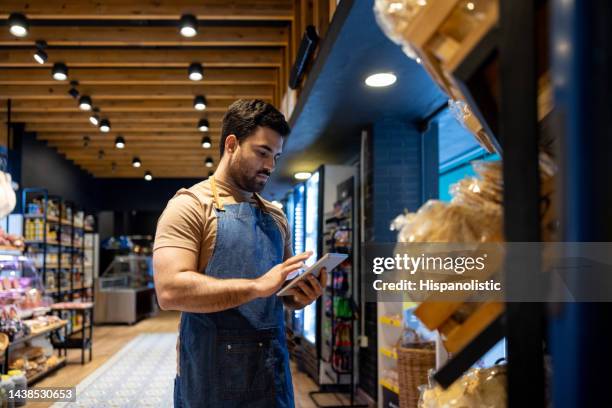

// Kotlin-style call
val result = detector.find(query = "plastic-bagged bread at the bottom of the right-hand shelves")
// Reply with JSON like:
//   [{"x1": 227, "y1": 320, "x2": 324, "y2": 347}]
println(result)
[{"x1": 419, "y1": 365, "x2": 507, "y2": 408}]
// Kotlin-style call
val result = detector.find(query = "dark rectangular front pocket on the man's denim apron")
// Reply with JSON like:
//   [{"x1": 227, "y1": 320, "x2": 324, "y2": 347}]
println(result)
[{"x1": 217, "y1": 330, "x2": 275, "y2": 401}]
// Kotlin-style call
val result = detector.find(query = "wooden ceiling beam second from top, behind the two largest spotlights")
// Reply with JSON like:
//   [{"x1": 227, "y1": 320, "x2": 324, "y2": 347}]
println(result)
[{"x1": 0, "y1": 23, "x2": 289, "y2": 47}]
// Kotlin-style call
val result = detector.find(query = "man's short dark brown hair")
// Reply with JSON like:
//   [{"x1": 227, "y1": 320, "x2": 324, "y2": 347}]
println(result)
[{"x1": 220, "y1": 99, "x2": 291, "y2": 156}]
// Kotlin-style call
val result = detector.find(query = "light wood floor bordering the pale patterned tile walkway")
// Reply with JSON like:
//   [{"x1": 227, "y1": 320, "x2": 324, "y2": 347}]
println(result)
[{"x1": 28, "y1": 312, "x2": 317, "y2": 408}]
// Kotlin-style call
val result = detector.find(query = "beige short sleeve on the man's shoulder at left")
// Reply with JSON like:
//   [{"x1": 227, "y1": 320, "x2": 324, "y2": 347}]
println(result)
[{"x1": 154, "y1": 192, "x2": 204, "y2": 253}]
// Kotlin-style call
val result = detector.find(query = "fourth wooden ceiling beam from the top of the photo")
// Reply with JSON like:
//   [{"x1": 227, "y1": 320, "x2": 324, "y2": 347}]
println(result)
[{"x1": 0, "y1": 67, "x2": 277, "y2": 86}]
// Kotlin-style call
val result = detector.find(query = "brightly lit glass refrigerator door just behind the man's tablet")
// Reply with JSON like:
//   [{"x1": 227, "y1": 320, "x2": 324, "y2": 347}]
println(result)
[{"x1": 303, "y1": 172, "x2": 319, "y2": 344}]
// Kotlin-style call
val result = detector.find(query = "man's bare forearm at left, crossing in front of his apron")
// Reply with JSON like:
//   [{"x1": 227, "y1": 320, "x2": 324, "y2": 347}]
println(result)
[{"x1": 158, "y1": 271, "x2": 258, "y2": 313}]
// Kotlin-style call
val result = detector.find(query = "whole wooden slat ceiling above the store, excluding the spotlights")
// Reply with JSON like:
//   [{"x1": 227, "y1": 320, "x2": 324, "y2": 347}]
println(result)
[{"x1": 0, "y1": 0, "x2": 300, "y2": 178}]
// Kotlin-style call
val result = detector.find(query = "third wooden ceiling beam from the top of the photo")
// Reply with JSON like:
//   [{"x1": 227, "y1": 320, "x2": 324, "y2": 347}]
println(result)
[{"x1": 0, "y1": 47, "x2": 283, "y2": 67}]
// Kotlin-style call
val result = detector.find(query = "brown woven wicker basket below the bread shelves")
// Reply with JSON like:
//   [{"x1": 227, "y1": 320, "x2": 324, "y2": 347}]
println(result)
[{"x1": 397, "y1": 347, "x2": 436, "y2": 408}]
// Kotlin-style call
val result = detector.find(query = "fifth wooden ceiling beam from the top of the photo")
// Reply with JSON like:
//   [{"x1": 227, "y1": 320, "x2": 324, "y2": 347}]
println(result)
[{"x1": 0, "y1": 84, "x2": 274, "y2": 99}]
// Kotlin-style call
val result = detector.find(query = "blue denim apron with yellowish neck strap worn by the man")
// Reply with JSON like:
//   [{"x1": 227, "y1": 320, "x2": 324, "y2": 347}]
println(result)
[{"x1": 174, "y1": 177, "x2": 294, "y2": 408}]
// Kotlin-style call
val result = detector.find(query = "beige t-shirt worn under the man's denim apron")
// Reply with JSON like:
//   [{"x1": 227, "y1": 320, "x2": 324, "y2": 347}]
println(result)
[{"x1": 153, "y1": 175, "x2": 293, "y2": 273}]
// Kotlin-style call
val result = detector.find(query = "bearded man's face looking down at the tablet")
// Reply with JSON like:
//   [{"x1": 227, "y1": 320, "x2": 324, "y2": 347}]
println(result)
[{"x1": 225, "y1": 127, "x2": 283, "y2": 193}]
